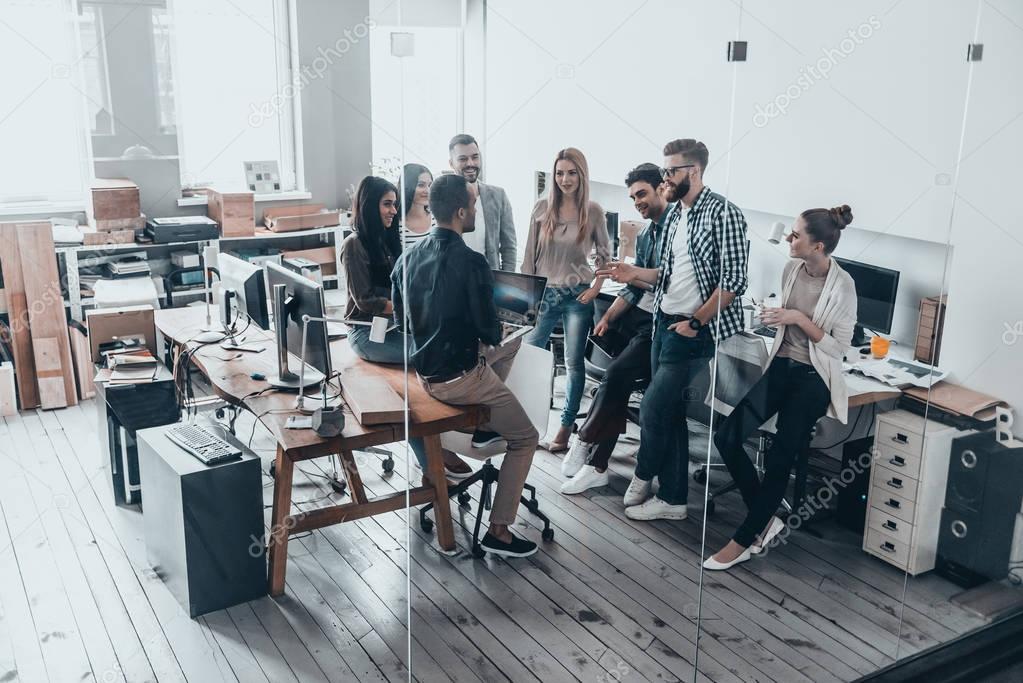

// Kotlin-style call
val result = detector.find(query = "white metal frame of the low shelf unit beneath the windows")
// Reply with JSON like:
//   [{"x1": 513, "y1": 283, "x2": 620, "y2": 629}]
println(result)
[{"x1": 55, "y1": 225, "x2": 348, "y2": 321}]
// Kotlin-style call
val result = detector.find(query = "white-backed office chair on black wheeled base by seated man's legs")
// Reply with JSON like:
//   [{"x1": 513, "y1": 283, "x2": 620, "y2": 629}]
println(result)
[{"x1": 419, "y1": 344, "x2": 554, "y2": 557}]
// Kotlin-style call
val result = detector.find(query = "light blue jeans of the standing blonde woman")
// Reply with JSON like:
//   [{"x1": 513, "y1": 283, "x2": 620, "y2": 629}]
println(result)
[{"x1": 526, "y1": 284, "x2": 593, "y2": 426}]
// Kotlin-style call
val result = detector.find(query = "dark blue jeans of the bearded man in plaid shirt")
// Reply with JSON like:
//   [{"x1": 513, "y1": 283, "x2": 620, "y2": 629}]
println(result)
[{"x1": 635, "y1": 316, "x2": 714, "y2": 505}]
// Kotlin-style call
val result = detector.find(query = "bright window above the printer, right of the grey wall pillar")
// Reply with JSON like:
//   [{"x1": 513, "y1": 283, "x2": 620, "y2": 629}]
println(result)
[{"x1": 169, "y1": 0, "x2": 304, "y2": 190}]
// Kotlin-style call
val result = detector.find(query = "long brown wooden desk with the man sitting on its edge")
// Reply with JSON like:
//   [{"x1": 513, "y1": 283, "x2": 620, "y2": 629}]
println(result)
[{"x1": 155, "y1": 307, "x2": 489, "y2": 595}]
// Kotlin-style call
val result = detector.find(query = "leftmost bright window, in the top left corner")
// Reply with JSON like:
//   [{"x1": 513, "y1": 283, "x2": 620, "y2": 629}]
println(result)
[{"x1": 0, "y1": 0, "x2": 89, "y2": 208}]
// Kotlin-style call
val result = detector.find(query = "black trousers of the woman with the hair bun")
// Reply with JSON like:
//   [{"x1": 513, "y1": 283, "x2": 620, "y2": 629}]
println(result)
[{"x1": 714, "y1": 357, "x2": 831, "y2": 548}]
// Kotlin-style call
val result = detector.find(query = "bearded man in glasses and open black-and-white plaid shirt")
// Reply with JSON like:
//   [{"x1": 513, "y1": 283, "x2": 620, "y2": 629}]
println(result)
[{"x1": 597, "y1": 139, "x2": 750, "y2": 519}]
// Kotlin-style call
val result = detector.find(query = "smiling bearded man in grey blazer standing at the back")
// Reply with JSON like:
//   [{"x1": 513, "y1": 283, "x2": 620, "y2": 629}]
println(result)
[{"x1": 448, "y1": 133, "x2": 518, "y2": 271}]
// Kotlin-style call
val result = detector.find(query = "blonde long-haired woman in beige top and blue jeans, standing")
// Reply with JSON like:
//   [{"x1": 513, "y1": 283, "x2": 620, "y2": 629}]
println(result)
[{"x1": 522, "y1": 147, "x2": 611, "y2": 453}]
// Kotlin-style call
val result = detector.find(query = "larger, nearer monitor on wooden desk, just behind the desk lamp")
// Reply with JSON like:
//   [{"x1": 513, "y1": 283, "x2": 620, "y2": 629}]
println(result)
[{"x1": 266, "y1": 263, "x2": 330, "y2": 388}]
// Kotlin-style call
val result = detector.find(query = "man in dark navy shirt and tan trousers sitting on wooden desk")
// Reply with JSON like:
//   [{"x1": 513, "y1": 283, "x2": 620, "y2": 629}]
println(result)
[{"x1": 391, "y1": 175, "x2": 539, "y2": 557}]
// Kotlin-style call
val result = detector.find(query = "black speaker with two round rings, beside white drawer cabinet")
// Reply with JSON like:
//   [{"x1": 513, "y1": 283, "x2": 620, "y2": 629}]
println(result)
[{"x1": 937, "y1": 431, "x2": 1023, "y2": 585}]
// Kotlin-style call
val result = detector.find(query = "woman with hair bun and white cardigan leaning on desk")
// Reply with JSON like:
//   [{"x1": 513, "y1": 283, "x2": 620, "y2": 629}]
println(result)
[{"x1": 704, "y1": 204, "x2": 856, "y2": 570}]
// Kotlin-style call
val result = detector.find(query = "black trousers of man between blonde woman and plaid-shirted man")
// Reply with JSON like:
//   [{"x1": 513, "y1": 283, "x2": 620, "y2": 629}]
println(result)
[{"x1": 579, "y1": 307, "x2": 654, "y2": 469}]
